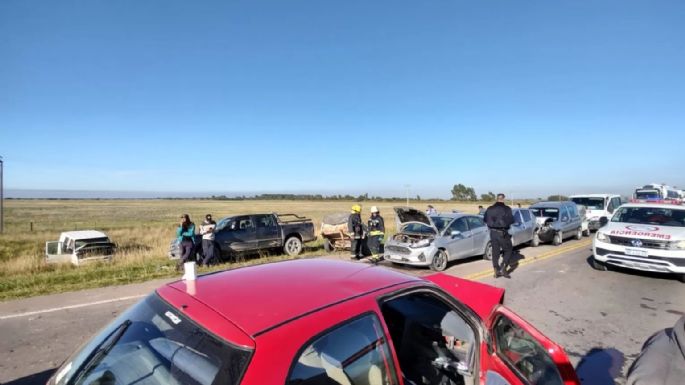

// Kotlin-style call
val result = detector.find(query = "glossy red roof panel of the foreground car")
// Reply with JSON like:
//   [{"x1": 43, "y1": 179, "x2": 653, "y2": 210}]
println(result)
[{"x1": 158, "y1": 259, "x2": 423, "y2": 337}]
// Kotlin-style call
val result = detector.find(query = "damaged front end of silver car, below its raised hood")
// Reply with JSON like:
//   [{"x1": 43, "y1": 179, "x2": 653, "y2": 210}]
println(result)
[{"x1": 384, "y1": 233, "x2": 437, "y2": 266}]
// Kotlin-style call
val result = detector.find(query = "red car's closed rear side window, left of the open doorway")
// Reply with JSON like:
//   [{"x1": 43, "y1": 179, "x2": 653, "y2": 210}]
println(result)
[{"x1": 286, "y1": 314, "x2": 397, "y2": 385}]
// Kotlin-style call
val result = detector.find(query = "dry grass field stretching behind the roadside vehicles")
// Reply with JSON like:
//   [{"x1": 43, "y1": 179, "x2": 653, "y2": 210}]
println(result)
[{"x1": 0, "y1": 200, "x2": 478, "y2": 300}]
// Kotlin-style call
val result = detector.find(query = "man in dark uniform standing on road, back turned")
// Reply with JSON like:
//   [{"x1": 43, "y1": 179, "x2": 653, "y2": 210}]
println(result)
[{"x1": 484, "y1": 194, "x2": 514, "y2": 278}]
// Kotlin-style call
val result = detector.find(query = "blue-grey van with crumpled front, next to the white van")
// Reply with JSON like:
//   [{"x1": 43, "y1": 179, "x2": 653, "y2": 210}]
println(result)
[{"x1": 530, "y1": 201, "x2": 583, "y2": 246}]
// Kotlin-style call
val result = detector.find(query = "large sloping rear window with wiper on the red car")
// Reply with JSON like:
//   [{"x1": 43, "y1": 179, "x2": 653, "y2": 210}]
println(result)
[{"x1": 51, "y1": 294, "x2": 251, "y2": 385}]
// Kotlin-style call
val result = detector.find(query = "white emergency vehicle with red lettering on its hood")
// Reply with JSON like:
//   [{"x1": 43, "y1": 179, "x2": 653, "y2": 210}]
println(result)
[{"x1": 592, "y1": 203, "x2": 685, "y2": 282}]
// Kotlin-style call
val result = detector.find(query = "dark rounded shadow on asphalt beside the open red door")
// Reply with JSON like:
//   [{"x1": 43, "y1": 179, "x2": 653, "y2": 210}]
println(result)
[{"x1": 576, "y1": 348, "x2": 625, "y2": 385}]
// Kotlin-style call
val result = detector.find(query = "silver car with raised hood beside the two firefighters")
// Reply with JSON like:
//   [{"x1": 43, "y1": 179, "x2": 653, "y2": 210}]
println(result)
[{"x1": 384, "y1": 207, "x2": 492, "y2": 271}]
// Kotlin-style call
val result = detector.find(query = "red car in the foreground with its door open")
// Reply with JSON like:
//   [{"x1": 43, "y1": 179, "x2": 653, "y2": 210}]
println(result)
[{"x1": 48, "y1": 259, "x2": 579, "y2": 385}]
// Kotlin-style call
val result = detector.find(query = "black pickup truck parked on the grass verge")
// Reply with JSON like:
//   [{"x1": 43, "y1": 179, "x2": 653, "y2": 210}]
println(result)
[{"x1": 169, "y1": 213, "x2": 316, "y2": 261}]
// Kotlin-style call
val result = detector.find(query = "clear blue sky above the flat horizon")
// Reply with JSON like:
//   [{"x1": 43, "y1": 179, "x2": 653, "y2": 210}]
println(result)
[{"x1": 0, "y1": 0, "x2": 685, "y2": 197}]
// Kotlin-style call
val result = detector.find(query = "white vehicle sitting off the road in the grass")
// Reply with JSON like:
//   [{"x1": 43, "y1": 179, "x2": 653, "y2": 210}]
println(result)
[{"x1": 45, "y1": 230, "x2": 116, "y2": 266}]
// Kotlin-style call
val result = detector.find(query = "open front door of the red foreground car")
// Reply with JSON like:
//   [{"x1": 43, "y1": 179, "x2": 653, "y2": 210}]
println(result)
[{"x1": 485, "y1": 305, "x2": 580, "y2": 385}]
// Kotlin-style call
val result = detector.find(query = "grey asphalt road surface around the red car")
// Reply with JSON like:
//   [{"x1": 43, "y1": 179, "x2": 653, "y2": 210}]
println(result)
[{"x1": 0, "y1": 239, "x2": 685, "y2": 385}]
